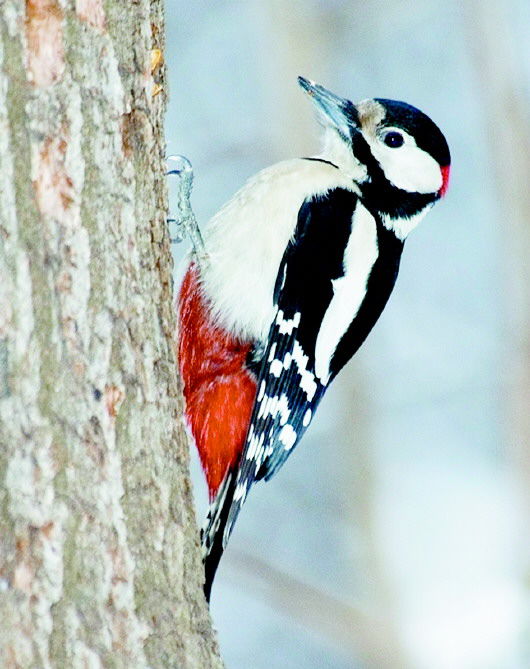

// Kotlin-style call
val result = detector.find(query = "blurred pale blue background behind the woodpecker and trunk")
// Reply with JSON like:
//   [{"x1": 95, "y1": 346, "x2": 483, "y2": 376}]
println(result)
[{"x1": 166, "y1": 0, "x2": 530, "y2": 669}]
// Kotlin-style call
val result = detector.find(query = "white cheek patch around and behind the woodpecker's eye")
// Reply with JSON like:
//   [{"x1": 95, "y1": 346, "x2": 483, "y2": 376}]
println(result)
[{"x1": 365, "y1": 130, "x2": 443, "y2": 193}]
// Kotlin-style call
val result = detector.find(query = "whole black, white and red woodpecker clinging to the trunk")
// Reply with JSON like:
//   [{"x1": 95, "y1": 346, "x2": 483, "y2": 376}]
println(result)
[{"x1": 178, "y1": 77, "x2": 450, "y2": 598}]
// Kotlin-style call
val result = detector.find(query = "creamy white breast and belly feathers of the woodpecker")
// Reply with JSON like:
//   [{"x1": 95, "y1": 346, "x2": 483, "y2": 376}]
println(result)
[{"x1": 198, "y1": 159, "x2": 356, "y2": 340}]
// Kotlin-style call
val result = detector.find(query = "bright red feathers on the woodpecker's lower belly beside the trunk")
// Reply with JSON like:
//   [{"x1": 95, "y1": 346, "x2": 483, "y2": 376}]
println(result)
[{"x1": 178, "y1": 264, "x2": 256, "y2": 499}]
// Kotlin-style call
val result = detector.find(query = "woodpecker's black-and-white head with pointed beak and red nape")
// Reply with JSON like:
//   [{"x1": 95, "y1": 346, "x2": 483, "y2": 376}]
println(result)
[{"x1": 298, "y1": 77, "x2": 450, "y2": 236}]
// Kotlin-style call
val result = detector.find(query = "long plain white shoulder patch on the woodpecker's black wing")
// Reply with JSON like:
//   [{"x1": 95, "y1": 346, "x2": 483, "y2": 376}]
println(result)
[{"x1": 315, "y1": 202, "x2": 379, "y2": 385}]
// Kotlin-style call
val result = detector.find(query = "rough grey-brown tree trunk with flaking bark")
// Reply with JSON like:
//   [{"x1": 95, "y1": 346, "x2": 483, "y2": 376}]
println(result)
[{"x1": 0, "y1": 0, "x2": 221, "y2": 669}]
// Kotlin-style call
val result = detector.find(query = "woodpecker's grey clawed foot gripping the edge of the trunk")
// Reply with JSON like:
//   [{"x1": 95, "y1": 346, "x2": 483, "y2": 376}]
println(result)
[{"x1": 166, "y1": 155, "x2": 208, "y2": 267}]
